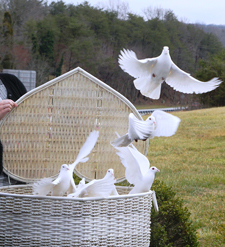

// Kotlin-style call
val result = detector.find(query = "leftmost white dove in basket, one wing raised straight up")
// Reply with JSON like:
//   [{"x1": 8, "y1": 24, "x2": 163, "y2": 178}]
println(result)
[{"x1": 33, "y1": 130, "x2": 99, "y2": 196}]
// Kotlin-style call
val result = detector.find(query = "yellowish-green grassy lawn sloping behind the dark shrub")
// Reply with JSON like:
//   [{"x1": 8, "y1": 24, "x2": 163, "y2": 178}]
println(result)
[{"x1": 143, "y1": 107, "x2": 225, "y2": 247}]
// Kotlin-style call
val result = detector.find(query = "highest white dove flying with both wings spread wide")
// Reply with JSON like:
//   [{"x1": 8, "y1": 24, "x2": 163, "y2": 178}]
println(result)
[{"x1": 118, "y1": 46, "x2": 222, "y2": 99}]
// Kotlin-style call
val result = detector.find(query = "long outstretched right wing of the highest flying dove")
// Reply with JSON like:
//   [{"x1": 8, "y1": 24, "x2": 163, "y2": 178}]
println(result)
[{"x1": 166, "y1": 63, "x2": 222, "y2": 94}]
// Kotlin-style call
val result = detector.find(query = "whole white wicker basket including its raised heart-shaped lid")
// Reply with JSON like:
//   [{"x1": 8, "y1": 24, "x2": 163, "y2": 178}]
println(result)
[{"x1": 0, "y1": 68, "x2": 152, "y2": 247}]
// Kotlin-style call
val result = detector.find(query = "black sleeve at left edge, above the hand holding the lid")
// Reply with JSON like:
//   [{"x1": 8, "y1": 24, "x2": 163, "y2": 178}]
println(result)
[{"x1": 0, "y1": 73, "x2": 27, "y2": 101}]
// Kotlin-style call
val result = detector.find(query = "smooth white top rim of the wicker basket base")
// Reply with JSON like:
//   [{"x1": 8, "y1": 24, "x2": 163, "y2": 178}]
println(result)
[{"x1": 0, "y1": 184, "x2": 155, "y2": 202}]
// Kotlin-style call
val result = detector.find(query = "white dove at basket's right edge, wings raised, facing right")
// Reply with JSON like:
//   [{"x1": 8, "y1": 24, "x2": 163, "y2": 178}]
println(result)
[{"x1": 116, "y1": 146, "x2": 160, "y2": 194}]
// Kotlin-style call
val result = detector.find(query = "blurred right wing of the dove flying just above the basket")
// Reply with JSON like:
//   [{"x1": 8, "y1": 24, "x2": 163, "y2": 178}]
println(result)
[{"x1": 151, "y1": 110, "x2": 180, "y2": 138}]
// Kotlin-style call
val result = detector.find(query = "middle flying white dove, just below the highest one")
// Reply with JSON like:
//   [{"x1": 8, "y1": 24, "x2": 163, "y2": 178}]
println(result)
[{"x1": 111, "y1": 110, "x2": 180, "y2": 147}]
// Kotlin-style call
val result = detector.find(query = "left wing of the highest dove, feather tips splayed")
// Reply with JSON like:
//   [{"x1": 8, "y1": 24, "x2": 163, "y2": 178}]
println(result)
[{"x1": 118, "y1": 49, "x2": 157, "y2": 78}]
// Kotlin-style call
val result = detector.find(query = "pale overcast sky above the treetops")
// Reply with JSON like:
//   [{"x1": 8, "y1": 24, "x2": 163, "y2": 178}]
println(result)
[{"x1": 51, "y1": 0, "x2": 225, "y2": 25}]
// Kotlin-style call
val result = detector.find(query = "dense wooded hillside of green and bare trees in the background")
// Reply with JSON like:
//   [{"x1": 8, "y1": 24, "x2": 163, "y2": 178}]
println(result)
[{"x1": 0, "y1": 0, "x2": 224, "y2": 104}]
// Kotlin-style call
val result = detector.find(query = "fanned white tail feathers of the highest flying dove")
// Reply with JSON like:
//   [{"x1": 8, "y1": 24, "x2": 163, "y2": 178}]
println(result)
[{"x1": 134, "y1": 76, "x2": 161, "y2": 99}]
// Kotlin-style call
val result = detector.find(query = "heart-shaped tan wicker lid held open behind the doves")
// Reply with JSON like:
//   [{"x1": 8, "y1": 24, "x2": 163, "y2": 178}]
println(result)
[{"x1": 0, "y1": 68, "x2": 148, "y2": 182}]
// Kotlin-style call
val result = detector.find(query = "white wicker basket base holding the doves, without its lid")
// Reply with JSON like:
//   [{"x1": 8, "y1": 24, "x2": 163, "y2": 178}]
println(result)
[{"x1": 0, "y1": 185, "x2": 152, "y2": 247}]
